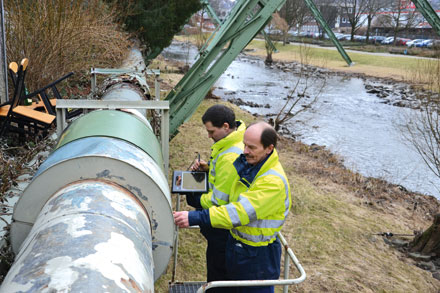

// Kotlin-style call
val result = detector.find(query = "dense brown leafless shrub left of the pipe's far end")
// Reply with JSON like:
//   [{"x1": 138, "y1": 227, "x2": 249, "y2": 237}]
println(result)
[{"x1": 5, "y1": 0, "x2": 129, "y2": 91}]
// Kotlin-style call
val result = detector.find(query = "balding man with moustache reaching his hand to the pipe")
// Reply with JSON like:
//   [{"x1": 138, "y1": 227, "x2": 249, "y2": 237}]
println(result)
[{"x1": 174, "y1": 122, "x2": 291, "y2": 293}]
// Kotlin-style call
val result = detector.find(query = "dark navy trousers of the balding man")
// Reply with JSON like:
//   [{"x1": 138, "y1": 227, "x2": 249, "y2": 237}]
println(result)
[{"x1": 226, "y1": 235, "x2": 281, "y2": 293}]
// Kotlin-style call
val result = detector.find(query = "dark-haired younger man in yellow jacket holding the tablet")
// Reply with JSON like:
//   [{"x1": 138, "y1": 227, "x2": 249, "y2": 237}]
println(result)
[{"x1": 186, "y1": 105, "x2": 246, "y2": 293}]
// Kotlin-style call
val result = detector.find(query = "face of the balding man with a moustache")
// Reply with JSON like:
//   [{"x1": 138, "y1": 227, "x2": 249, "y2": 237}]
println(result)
[{"x1": 243, "y1": 127, "x2": 273, "y2": 165}]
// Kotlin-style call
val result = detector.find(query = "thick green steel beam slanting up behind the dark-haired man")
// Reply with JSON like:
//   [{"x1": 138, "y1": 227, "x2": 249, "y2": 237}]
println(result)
[{"x1": 166, "y1": 0, "x2": 285, "y2": 136}]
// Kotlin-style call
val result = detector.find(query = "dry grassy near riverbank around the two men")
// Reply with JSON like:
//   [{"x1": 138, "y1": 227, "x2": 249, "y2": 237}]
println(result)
[{"x1": 156, "y1": 53, "x2": 440, "y2": 292}]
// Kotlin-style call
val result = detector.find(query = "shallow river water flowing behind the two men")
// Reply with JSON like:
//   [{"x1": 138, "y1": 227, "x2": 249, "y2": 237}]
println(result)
[{"x1": 162, "y1": 43, "x2": 440, "y2": 198}]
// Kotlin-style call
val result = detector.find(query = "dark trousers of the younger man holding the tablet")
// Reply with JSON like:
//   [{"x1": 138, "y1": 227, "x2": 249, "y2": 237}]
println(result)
[{"x1": 200, "y1": 227, "x2": 230, "y2": 293}]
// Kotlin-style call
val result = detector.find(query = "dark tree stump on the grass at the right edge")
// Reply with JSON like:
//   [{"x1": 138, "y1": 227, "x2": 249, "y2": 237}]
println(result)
[{"x1": 409, "y1": 214, "x2": 440, "y2": 257}]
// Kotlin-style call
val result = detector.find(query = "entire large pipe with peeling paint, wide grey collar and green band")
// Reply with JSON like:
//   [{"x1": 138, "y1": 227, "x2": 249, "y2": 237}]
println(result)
[{"x1": 0, "y1": 47, "x2": 174, "y2": 293}]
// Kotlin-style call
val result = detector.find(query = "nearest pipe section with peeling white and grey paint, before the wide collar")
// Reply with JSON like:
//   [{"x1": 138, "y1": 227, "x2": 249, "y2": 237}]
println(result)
[{"x1": 1, "y1": 180, "x2": 154, "y2": 292}]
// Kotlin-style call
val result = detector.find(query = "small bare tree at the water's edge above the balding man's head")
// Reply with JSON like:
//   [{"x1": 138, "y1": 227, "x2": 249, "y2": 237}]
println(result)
[{"x1": 269, "y1": 45, "x2": 326, "y2": 131}]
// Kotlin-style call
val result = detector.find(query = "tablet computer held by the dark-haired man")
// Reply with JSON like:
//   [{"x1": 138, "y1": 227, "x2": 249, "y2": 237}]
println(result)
[{"x1": 171, "y1": 171, "x2": 208, "y2": 193}]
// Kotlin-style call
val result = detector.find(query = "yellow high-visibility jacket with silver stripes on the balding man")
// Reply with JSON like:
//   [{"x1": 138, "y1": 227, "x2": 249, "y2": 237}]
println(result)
[{"x1": 209, "y1": 149, "x2": 291, "y2": 246}]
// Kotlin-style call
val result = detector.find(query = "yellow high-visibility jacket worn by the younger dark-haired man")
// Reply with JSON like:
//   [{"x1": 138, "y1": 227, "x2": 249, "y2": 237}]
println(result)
[{"x1": 200, "y1": 121, "x2": 246, "y2": 209}]
